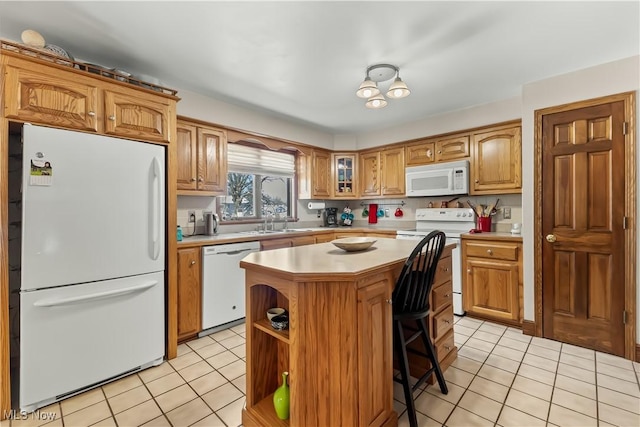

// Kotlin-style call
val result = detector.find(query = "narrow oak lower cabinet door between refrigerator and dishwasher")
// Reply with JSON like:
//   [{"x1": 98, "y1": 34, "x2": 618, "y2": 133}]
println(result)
[{"x1": 178, "y1": 248, "x2": 202, "y2": 341}]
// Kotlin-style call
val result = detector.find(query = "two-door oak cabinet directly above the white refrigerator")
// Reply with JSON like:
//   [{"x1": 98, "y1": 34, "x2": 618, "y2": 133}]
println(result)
[{"x1": 0, "y1": 51, "x2": 177, "y2": 144}]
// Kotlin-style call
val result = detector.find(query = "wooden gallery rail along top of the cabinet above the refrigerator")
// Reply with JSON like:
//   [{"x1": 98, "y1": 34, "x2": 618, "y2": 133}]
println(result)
[{"x1": 0, "y1": 39, "x2": 178, "y2": 96}]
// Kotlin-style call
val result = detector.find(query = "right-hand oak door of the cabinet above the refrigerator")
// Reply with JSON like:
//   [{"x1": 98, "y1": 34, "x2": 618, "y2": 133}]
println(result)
[{"x1": 104, "y1": 90, "x2": 172, "y2": 142}]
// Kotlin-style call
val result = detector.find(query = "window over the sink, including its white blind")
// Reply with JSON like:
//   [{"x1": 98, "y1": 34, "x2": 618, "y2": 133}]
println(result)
[{"x1": 219, "y1": 144, "x2": 295, "y2": 221}]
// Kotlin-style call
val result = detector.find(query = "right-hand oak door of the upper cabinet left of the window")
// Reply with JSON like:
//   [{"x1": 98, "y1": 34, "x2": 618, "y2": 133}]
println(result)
[{"x1": 197, "y1": 127, "x2": 227, "y2": 194}]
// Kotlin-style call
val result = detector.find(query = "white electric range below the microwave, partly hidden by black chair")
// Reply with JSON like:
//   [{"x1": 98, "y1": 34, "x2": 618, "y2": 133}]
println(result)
[{"x1": 396, "y1": 208, "x2": 476, "y2": 316}]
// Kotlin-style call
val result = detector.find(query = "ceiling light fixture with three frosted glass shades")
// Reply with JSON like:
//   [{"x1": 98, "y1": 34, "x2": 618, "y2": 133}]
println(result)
[{"x1": 356, "y1": 64, "x2": 411, "y2": 109}]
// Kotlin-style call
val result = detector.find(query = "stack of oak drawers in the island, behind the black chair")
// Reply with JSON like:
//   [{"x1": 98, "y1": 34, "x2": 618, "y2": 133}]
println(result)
[{"x1": 408, "y1": 247, "x2": 458, "y2": 384}]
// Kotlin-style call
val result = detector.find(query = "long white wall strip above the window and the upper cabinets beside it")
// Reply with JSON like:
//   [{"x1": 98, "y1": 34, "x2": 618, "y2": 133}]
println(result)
[{"x1": 178, "y1": 89, "x2": 333, "y2": 149}]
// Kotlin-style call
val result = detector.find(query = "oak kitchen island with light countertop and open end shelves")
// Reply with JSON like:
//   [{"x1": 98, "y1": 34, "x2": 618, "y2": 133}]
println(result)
[{"x1": 240, "y1": 238, "x2": 452, "y2": 426}]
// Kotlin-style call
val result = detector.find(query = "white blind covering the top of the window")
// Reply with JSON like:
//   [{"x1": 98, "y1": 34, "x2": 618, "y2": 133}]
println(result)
[{"x1": 227, "y1": 144, "x2": 296, "y2": 178}]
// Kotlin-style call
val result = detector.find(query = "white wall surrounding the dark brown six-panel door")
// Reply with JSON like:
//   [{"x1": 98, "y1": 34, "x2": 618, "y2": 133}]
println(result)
[{"x1": 522, "y1": 56, "x2": 640, "y2": 342}]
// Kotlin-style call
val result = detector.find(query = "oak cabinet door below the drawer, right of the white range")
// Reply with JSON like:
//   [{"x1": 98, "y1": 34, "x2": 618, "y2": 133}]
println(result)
[{"x1": 463, "y1": 258, "x2": 520, "y2": 322}]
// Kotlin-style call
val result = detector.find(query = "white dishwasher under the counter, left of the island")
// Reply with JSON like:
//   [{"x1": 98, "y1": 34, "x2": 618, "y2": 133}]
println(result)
[{"x1": 202, "y1": 242, "x2": 260, "y2": 331}]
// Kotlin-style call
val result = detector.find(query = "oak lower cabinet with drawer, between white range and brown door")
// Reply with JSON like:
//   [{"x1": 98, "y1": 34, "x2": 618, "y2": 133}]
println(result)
[{"x1": 461, "y1": 236, "x2": 523, "y2": 326}]
